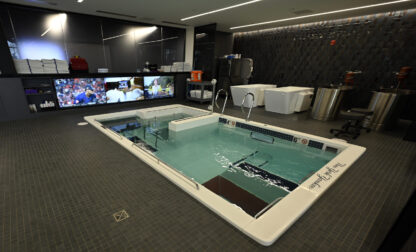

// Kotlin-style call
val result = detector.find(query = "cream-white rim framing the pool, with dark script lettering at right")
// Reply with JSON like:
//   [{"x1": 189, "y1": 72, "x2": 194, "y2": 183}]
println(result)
[{"x1": 84, "y1": 104, "x2": 365, "y2": 246}]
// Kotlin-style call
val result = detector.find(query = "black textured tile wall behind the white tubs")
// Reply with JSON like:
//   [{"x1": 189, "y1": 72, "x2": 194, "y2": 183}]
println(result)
[{"x1": 233, "y1": 9, "x2": 416, "y2": 90}]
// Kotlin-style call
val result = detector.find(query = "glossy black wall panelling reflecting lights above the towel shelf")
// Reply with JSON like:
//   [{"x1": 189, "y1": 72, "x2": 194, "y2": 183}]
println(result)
[{"x1": 0, "y1": 3, "x2": 185, "y2": 74}]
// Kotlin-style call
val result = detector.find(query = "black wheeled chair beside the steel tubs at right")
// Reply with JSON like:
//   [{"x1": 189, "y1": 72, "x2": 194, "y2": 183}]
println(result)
[{"x1": 329, "y1": 108, "x2": 373, "y2": 139}]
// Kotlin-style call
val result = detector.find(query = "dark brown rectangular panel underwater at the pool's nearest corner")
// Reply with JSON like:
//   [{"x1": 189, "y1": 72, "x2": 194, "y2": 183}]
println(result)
[{"x1": 203, "y1": 176, "x2": 268, "y2": 217}]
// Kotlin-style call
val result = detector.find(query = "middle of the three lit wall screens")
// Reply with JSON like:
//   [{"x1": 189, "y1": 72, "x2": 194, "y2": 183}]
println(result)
[{"x1": 104, "y1": 77, "x2": 144, "y2": 103}]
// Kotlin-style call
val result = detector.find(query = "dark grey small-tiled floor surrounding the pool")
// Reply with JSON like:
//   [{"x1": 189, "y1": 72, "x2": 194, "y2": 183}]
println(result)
[{"x1": 0, "y1": 101, "x2": 416, "y2": 251}]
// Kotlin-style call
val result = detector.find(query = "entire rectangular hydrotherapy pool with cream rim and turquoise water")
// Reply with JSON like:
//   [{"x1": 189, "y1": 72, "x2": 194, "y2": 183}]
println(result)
[{"x1": 85, "y1": 105, "x2": 365, "y2": 245}]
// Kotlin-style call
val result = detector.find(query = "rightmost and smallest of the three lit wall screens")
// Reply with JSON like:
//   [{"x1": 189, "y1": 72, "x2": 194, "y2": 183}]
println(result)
[{"x1": 144, "y1": 76, "x2": 175, "y2": 99}]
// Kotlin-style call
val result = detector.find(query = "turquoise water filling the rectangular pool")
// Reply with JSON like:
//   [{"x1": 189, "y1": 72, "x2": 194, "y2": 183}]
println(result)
[{"x1": 104, "y1": 114, "x2": 336, "y2": 208}]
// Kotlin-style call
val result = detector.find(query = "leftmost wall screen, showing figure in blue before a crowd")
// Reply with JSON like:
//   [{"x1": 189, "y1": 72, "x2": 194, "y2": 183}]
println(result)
[{"x1": 54, "y1": 78, "x2": 107, "y2": 108}]
